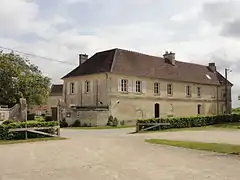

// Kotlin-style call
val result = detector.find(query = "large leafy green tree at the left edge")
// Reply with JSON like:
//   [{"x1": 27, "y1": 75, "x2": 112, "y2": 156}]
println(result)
[{"x1": 0, "y1": 51, "x2": 50, "y2": 106}]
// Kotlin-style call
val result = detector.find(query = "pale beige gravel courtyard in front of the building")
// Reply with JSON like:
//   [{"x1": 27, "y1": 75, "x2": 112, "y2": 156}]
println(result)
[{"x1": 0, "y1": 129, "x2": 240, "y2": 180}]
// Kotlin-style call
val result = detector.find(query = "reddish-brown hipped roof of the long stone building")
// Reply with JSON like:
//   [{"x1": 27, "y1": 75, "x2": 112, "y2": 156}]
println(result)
[{"x1": 62, "y1": 49, "x2": 232, "y2": 85}]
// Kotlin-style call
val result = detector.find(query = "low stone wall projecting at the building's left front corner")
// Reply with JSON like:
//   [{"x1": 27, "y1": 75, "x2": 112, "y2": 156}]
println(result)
[{"x1": 65, "y1": 109, "x2": 109, "y2": 126}]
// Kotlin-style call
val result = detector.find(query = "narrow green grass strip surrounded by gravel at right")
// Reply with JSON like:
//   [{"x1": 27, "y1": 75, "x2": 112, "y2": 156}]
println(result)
[{"x1": 146, "y1": 139, "x2": 240, "y2": 155}]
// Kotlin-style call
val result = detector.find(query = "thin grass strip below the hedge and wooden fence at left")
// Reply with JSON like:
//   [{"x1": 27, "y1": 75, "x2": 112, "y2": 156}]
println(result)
[{"x1": 0, "y1": 137, "x2": 67, "y2": 145}]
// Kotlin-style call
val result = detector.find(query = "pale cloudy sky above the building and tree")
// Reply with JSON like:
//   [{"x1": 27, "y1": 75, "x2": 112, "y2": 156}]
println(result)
[{"x1": 0, "y1": 0, "x2": 240, "y2": 107}]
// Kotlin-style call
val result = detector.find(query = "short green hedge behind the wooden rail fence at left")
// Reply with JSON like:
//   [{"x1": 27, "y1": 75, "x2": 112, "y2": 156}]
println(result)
[{"x1": 0, "y1": 121, "x2": 58, "y2": 140}]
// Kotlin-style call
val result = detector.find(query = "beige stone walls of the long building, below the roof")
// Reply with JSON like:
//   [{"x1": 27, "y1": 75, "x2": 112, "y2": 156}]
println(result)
[{"x1": 63, "y1": 73, "x2": 231, "y2": 124}]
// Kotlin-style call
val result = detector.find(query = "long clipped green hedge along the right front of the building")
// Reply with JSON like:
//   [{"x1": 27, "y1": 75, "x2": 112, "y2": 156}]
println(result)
[{"x1": 137, "y1": 114, "x2": 240, "y2": 131}]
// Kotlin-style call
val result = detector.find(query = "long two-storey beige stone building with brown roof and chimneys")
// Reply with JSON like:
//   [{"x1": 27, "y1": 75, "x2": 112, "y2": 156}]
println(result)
[{"x1": 62, "y1": 49, "x2": 232, "y2": 125}]
